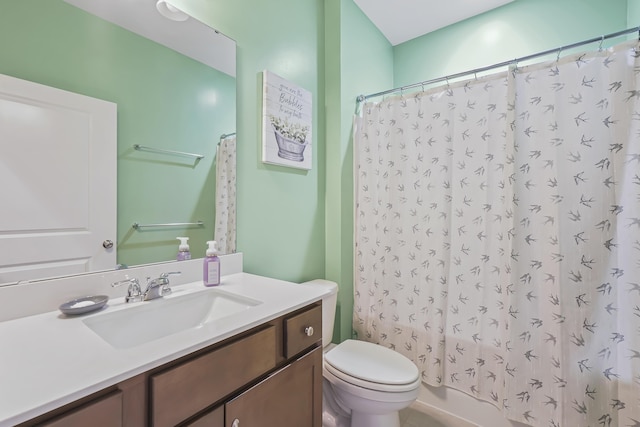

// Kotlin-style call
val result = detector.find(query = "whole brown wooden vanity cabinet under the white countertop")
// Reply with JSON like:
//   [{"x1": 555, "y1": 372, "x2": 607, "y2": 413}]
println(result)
[{"x1": 21, "y1": 302, "x2": 322, "y2": 427}]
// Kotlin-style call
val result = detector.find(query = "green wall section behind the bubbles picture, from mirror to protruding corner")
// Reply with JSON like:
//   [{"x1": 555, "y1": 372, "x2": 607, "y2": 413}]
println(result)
[{"x1": 175, "y1": 0, "x2": 326, "y2": 282}]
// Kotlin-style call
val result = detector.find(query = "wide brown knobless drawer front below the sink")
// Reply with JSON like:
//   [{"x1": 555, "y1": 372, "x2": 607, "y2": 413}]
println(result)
[{"x1": 150, "y1": 326, "x2": 276, "y2": 427}]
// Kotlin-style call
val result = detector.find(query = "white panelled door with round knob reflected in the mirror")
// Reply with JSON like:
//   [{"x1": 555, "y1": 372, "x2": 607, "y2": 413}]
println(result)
[{"x1": 0, "y1": 74, "x2": 117, "y2": 284}]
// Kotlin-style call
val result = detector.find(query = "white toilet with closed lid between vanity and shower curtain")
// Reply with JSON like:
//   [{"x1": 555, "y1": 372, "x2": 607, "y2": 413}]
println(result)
[{"x1": 305, "y1": 280, "x2": 420, "y2": 427}]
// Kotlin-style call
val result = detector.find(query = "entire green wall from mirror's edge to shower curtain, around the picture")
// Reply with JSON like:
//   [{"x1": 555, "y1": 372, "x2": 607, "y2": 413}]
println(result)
[{"x1": 175, "y1": 0, "x2": 393, "y2": 340}]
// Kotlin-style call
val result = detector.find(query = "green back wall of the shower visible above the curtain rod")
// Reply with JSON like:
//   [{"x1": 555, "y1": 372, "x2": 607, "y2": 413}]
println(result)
[{"x1": 394, "y1": 0, "x2": 638, "y2": 86}]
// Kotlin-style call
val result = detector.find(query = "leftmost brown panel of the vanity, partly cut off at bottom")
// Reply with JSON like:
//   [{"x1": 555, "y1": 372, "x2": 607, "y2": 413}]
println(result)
[{"x1": 39, "y1": 391, "x2": 122, "y2": 427}]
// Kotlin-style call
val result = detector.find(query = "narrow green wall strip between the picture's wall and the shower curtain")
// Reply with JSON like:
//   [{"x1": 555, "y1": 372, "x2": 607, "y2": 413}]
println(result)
[{"x1": 325, "y1": 0, "x2": 393, "y2": 342}]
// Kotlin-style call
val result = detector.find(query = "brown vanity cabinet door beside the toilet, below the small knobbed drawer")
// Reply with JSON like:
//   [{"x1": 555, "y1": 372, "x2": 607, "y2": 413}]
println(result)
[{"x1": 225, "y1": 347, "x2": 322, "y2": 427}]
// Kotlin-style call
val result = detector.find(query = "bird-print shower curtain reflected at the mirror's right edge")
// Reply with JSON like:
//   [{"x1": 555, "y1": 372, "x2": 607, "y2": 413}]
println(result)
[{"x1": 214, "y1": 136, "x2": 236, "y2": 254}]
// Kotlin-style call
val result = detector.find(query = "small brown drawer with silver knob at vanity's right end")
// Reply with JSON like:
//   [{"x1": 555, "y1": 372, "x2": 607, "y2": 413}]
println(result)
[{"x1": 284, "y1": 305, "x2": 322, "y2": 358}]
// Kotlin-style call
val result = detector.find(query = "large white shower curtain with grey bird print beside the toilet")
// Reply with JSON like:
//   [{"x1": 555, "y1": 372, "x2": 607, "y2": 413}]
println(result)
[{"x1": 354, "y1": 39, "x2": 640, "y2": 427}]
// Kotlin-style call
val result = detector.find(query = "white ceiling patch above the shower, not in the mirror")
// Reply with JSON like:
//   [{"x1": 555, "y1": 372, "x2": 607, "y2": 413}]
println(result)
[{"x1": 354, "y1": 0, "x2": 514, "y2": 46}]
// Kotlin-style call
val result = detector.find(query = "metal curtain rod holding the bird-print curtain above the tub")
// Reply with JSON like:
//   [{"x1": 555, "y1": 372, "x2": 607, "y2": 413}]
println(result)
[{"x1": 356, "y1": 27, "x2": 640, "y2": 103}]
